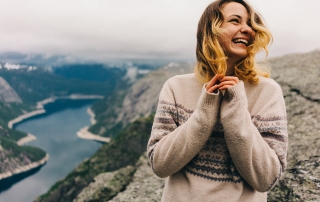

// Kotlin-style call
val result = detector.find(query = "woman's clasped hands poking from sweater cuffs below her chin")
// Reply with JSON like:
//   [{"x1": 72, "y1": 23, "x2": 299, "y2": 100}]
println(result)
[{"x1": 206, "y1": 74, "x2": 239, "y2": 93}]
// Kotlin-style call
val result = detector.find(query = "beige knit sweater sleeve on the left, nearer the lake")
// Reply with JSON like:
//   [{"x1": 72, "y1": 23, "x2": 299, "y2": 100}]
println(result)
[{"x1": 147, "y1": 78, "x2": 221, "y2": 177}]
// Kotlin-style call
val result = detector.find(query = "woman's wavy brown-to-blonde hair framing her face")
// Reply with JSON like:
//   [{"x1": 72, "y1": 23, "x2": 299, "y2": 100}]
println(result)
[{"x1": 194, "y1": 0, "x2": 272, "y2": 84}]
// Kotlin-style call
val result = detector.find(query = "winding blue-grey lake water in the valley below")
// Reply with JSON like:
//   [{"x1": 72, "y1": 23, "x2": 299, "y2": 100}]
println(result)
[{"x1": 0, "y1": 100, "x2": 102, "y2": 202}]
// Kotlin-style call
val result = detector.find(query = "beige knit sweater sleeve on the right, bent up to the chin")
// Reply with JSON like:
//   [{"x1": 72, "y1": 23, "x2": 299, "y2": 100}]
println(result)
[{"x1": 220, "y1": 81, "x2": 288, "y2": 192}]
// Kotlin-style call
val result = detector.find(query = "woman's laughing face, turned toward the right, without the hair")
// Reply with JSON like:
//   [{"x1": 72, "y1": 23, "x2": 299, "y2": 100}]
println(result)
[{"x1": 220, "y1": 2, "x2": 254, "y2": 65}]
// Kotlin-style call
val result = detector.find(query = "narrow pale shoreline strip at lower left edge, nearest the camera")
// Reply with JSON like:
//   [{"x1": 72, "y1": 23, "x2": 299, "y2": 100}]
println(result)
[{"x1": 0, "y1": 154, "x2": 49, "y2": 180}]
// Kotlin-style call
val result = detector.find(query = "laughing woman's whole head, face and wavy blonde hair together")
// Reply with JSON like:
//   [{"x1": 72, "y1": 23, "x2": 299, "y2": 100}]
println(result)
[{"x1": 194, "y1": 0, "x2": 272, "y2": 83}]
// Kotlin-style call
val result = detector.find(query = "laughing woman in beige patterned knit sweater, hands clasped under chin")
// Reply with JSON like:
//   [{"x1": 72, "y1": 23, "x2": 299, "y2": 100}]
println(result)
[{"x1": 148, "y1": 0, "x2": 288, "y2": 202}]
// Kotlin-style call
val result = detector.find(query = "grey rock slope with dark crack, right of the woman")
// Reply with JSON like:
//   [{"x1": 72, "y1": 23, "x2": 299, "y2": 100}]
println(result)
[{"x1": 269, "y1": 51, "x2": 320, "y2": 201}]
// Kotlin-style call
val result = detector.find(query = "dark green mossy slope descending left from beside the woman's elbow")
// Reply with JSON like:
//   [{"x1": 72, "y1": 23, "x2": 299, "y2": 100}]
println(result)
[{"x1": 35, "y1": 116, "x2": 153, "y2": 202}]
